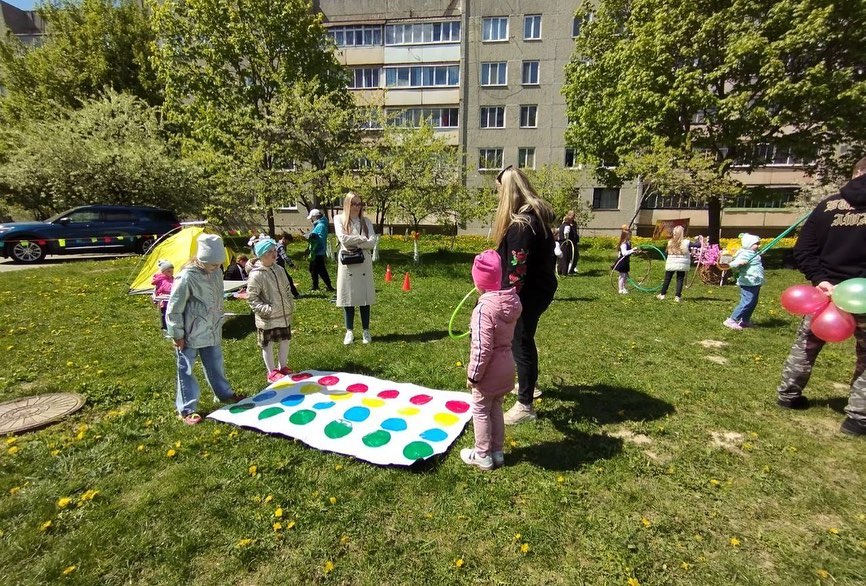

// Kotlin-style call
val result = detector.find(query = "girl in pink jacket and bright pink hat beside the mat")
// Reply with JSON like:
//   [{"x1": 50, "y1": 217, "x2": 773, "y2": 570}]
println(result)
[{"x1": 460, "y1": 250, "x2": 521, "y2": 470}]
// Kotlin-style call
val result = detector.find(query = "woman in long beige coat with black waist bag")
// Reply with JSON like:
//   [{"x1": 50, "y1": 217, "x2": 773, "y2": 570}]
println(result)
[{"x1": 334, "y1": 191, "x2": 378, "y2": 344}]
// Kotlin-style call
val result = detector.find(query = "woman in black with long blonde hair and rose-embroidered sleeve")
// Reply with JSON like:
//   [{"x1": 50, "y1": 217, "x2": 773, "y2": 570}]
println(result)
[{"x1": 492, "y1": 166, "x2": 557, "y2": 425}]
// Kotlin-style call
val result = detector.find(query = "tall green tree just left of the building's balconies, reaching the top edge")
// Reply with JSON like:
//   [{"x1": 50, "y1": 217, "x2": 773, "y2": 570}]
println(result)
[{"x1": 151, "y1": 0, "x2": 350, "y2": 233}]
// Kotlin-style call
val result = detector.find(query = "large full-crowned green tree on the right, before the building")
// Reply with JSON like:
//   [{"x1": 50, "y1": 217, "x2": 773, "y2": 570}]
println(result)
[{"x1": 563, "y1": 0, "x2": 866, "y2": 241}]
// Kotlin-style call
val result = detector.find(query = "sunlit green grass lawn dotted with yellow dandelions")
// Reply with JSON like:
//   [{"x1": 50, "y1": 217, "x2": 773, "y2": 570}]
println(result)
[{"x1": 0, "y1": 239, "x2": 866, "y2": 586}]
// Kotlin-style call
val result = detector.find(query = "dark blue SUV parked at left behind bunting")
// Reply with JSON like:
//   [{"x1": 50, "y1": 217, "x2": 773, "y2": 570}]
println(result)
[{"x1": 0, "y1": 205, "x2": 180, "y2": 263}]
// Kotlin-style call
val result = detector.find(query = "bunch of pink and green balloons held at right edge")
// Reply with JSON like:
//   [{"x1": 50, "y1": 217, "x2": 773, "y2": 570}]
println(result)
[{"x1": 782, "y1": 278, "x2": 866, "y2": 342}]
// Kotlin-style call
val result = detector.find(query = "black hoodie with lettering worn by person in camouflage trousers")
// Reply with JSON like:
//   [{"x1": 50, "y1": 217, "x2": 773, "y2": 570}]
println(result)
[{"x1": 794, "y1": 175, "x2": 866, "y2": 285}]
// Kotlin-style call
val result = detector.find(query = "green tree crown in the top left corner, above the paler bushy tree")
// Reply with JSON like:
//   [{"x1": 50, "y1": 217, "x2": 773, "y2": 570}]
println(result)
[{"x1": 0, "y1": 0, "x2": 162, "y2": 124}]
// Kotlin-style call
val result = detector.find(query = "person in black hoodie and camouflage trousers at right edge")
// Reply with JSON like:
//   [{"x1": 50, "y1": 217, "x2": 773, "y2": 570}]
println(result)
[{"x1": 776, "y1": 158, "x2": 866, "y2": 436}]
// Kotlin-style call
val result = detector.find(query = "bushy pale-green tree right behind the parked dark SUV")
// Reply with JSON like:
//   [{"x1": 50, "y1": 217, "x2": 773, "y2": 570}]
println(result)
[{"x1": 0, "y1": 93, "x2": 201, "y2": 219}]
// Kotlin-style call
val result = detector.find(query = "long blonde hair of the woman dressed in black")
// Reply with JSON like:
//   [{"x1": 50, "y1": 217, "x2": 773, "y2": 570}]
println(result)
[{"x1": 491, "y1": 167, "x2": 556, "y2": 247}]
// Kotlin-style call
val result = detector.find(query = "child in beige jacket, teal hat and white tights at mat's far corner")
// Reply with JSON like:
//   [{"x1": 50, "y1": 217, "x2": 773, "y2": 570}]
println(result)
[{"x1": 247, "y1": 238, "x2": 295, "y2": 382}]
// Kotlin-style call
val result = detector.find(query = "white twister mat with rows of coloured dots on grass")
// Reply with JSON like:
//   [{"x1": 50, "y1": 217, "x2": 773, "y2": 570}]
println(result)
[{"x1": 208, "y1": 370, "x2": 472, "y2": 466}]
